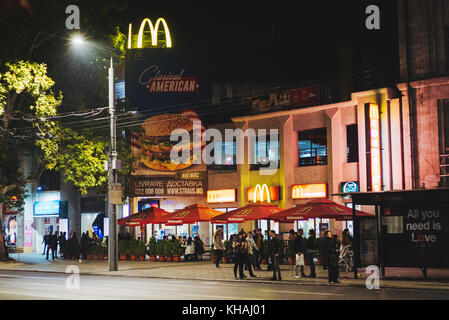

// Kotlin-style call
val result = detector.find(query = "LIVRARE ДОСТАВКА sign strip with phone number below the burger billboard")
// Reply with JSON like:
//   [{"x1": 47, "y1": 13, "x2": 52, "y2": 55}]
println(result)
[{"x1": 129, "y1": 177, "x2": 207, "y2": 197}]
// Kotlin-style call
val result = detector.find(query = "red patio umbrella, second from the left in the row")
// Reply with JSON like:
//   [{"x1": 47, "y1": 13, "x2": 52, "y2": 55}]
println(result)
[{"x1": 162, "y1": 204, "x2": 223, "y2": 226}]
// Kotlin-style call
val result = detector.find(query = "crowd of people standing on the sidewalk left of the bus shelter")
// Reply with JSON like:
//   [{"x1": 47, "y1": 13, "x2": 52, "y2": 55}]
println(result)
[{"x1": 213, "y1": 227, "x2": 352, "y2": 283}]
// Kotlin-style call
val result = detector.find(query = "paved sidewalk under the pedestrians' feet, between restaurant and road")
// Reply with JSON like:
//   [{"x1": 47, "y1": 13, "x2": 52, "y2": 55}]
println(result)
[{"x1": 0, "y1": 253, "x2": 449, "y2": 290}]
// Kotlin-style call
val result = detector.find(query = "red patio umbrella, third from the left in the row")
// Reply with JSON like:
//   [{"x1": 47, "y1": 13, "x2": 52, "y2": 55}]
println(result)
[{"x1": 211, "y1": 202, "x2": 282, "y2": 223}]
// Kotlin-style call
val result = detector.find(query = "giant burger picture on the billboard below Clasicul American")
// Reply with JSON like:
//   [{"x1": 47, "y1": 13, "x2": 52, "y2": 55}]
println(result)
[{"x1": 132, "y1": 111, "x2": 203, "y2": 171}]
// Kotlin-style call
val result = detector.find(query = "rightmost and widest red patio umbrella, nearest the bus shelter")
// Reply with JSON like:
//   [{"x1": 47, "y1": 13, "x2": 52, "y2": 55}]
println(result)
[{"x1": 269, "y1": 198, "x2": 373, "y2": 222}]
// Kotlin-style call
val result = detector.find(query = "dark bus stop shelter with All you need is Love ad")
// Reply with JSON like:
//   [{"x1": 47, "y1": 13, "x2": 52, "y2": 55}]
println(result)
[{"x1": 341, "y1": 188, "x2": 449, "y2": 278}]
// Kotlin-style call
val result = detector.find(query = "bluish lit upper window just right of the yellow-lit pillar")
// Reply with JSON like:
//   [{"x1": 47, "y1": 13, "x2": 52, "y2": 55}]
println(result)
[{"x1": 298, "y1": 128, "x2": 327, "y2": 167}]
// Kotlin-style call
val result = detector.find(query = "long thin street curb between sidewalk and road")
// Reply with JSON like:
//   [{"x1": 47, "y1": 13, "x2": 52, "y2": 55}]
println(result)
[{"x1": 0, "y1": 268, "x2": 449, "y2": 291}]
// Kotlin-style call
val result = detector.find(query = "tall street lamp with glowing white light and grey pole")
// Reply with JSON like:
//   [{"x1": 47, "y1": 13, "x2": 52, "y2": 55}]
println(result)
[{"x1": 71, "y1": 35, "x2": 118, "y2": 271}]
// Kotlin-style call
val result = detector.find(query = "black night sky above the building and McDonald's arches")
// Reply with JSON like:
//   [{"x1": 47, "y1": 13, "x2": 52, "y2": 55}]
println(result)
[{"x1": 122, "y1": 0, "x2": 398, "y2": 82}]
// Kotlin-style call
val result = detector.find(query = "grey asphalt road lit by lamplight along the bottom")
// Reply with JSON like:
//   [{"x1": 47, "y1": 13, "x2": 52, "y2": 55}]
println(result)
[{"x1": 0, "y1": 271, "x2": 449, "y2": 300}]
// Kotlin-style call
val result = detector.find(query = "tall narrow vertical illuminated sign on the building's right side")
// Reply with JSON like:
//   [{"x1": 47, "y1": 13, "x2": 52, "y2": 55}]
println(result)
[{"x1": 365, "y1": 103, "x2": 382, "y2": 192}]
